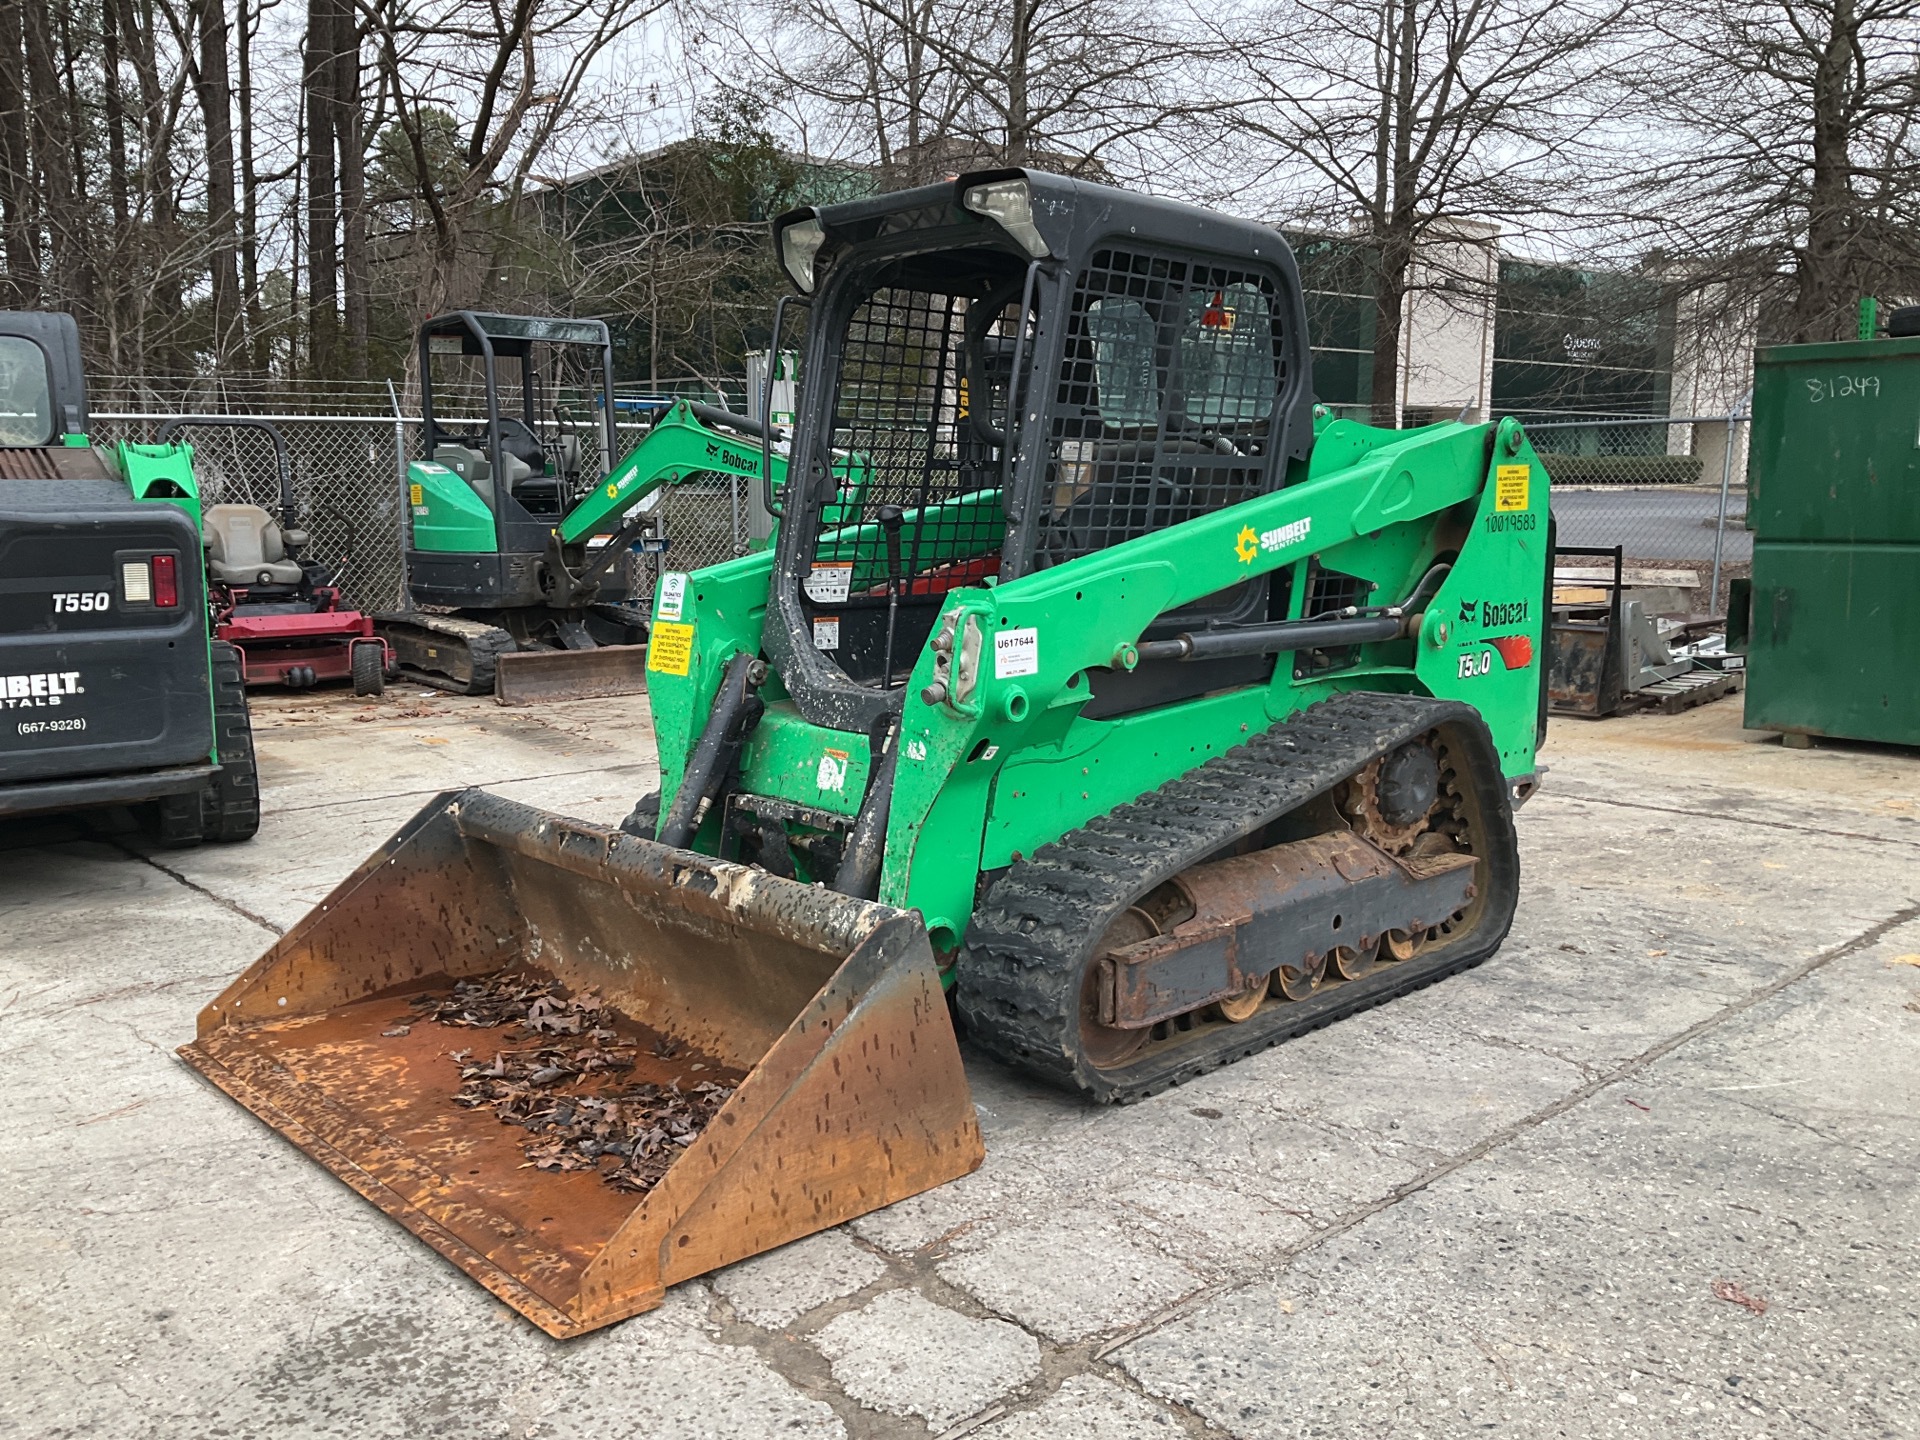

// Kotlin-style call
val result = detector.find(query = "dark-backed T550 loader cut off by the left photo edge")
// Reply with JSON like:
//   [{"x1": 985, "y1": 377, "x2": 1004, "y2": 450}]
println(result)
[{"x1": 0, "y1": 311, "x2": 259, "y2": 845}]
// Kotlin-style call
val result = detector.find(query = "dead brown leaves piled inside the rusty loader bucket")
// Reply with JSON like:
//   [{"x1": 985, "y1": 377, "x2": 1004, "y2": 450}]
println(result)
[{"x1": 401, "y1": 972, "x2": 733, "y2": 1194}]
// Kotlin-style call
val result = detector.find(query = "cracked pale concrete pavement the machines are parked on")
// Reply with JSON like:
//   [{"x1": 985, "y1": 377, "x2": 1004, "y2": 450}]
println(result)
[{"x1": 0, "y1": 691, "x2": 1920, "y2": 1440}]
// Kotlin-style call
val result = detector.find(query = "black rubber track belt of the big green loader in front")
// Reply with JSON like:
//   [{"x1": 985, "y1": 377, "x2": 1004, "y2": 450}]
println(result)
[{"x1": 956, "y1": 691, "x2": 1519, "y2": 1104}]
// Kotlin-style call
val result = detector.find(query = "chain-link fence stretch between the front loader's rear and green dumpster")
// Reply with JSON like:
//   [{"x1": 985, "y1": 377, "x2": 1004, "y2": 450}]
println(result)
[{"x1": 1526, "y1": 409, "x2": 1753, "y2": 614}]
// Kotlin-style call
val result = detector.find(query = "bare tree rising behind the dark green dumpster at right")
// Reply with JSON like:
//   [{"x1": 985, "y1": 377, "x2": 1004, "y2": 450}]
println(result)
[{"x1": 1617, "y1": 0, "x2": 1920, "y2": 340}]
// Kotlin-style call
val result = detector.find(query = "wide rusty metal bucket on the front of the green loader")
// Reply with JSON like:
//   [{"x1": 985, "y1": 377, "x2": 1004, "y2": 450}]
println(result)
[{"x1": 180, "y1": 789, "x2": 983, "y2": 1336}]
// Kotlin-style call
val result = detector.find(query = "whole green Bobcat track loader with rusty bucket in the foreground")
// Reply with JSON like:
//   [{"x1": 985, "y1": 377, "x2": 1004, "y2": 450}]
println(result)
[{"x1": 186, "y1": 171, "x2": 1551, "y2": 1334}]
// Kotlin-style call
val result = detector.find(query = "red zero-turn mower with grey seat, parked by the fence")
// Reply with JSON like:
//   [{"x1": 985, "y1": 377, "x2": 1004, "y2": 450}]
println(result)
[{"x1": 156, "y1": 415, "x2": 396, "y2": 695}]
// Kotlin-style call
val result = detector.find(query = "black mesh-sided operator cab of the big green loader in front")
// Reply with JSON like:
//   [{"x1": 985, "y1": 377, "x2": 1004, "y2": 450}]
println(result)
[{"x1": 766, "y1": 171, "x2": 1313, "y2": 730}]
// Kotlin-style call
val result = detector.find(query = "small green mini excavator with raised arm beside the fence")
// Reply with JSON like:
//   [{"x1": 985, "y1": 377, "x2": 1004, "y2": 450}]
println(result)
[{"x1": 378, "y1": 311, "x2": 833, "y2": 701}]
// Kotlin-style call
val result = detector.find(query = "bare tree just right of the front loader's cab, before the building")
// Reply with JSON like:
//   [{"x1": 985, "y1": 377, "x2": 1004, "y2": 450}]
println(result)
[{"x1": 1196, "y1": 0, "x2": 1626, "y2": 424}]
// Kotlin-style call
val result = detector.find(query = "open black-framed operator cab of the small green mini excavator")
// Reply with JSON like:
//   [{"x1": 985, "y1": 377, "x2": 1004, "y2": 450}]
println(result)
[{"x1": 420, "y1": 311, "x2": 612, "y2": 522}]
